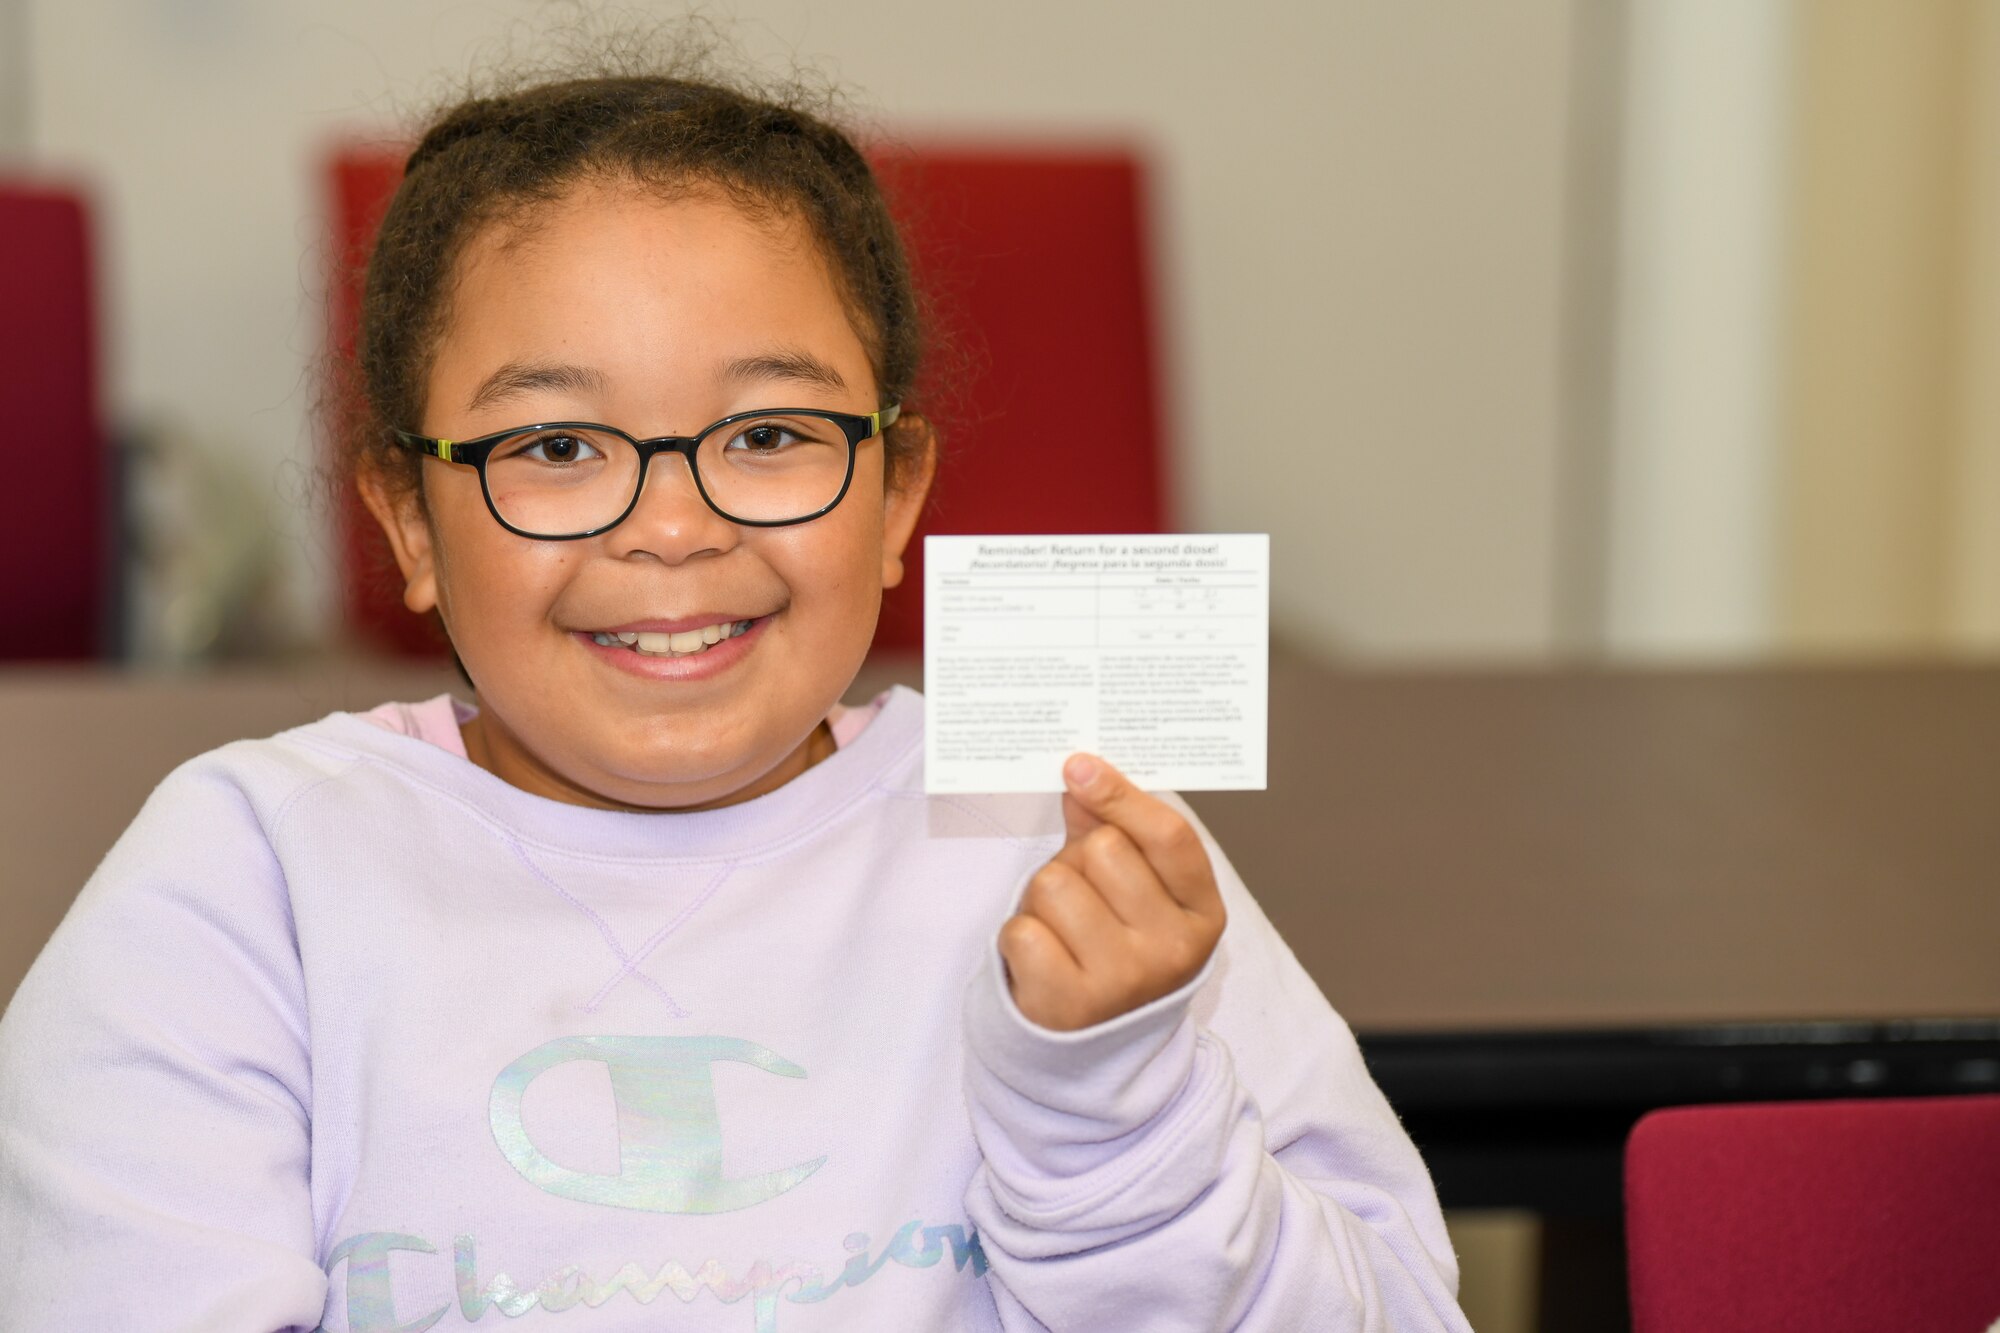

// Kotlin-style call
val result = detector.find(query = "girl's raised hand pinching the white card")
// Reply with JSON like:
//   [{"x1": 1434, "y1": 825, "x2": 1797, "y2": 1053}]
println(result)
[{"x1": 1000, "y1": 755, "x2": 1226, "y2": 1031}]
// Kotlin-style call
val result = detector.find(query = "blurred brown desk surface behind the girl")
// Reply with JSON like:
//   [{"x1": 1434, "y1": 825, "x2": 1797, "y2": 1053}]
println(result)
[{"x1": 0, "y1": 652, "x2": 2000, "y2": 1020}]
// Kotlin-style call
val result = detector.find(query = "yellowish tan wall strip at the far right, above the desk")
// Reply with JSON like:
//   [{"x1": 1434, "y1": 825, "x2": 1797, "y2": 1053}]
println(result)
[{"x1": 1776, "y1": 0, "x2": 2000, "y2": 654}]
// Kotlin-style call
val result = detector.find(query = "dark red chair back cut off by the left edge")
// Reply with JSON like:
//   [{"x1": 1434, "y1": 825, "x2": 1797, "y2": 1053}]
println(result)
[{"x1": 0, "y1": 184, "x2": 112, "y2": 660}]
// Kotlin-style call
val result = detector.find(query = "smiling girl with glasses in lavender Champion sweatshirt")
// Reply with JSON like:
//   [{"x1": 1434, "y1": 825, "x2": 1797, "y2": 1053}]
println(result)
[{"x1": 0, "y1": 57, "x2": 1464, "y2": 1333}]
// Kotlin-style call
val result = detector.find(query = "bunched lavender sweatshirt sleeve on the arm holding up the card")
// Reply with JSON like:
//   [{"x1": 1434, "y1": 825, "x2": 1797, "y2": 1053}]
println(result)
[{"x1": 966, "y1": 805, "x2": 1468, "y2": 1333}]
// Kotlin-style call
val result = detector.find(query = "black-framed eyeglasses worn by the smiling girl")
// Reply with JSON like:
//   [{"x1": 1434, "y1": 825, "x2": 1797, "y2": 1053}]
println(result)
[{"x1": 390, "y1": 404, "x2": 902, "y2": 542}]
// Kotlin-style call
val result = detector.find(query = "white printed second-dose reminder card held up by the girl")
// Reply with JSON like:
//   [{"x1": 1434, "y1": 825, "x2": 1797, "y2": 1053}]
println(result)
[{"x1": 924, "y1": 532, "x2": 1270, "y2": 795}]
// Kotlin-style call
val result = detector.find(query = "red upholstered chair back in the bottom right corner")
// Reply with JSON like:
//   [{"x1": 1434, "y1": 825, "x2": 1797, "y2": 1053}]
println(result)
[{"x1": 1626, "y1": 1097, "x2": 2000, "y2": 1333}]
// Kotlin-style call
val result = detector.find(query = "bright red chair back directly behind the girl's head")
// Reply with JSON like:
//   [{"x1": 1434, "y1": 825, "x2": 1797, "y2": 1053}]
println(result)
[{"x1": 330, "y1": 148, "x2": 1168, "y2": 652}]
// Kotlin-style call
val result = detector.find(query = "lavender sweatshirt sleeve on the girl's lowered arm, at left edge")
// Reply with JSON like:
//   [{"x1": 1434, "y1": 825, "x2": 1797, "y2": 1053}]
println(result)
[{"x1": 0, "y1": 761, "x2": 326, "y2": 1333}]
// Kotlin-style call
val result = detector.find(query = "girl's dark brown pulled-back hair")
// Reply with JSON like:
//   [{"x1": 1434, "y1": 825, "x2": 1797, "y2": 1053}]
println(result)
[{"x1": 344, "y1": 52, "x2": 928, "y2": 504}]
